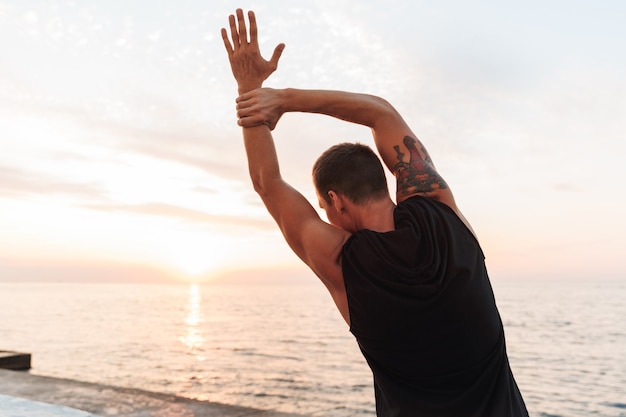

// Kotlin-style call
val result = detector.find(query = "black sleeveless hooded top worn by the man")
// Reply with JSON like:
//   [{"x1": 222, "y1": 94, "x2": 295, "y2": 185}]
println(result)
[{"x1": 342, "y1": 196, "x2": 528, "y2": 417}]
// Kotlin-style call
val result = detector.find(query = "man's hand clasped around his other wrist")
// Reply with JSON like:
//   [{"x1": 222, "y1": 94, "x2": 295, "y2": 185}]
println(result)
[{"x1": 237, "y1": 88, "x2": 285, "y2": 130}]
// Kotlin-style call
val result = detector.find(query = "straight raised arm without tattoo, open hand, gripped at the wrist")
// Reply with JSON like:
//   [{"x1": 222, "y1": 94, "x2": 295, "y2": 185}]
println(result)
[{"x1": 222, "y1": 9, "x2": 349, "y2": 322}]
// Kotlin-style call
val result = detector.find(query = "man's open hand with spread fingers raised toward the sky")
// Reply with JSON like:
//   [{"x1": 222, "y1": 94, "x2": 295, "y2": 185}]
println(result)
[{"x1": 222, "y1": 9, "x2": 285, "y2": 94}]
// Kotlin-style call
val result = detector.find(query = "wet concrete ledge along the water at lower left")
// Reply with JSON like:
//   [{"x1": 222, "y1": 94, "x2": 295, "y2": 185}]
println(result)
[{"x1": 0, "y1": 369, "x2": 303, "y2": 417}]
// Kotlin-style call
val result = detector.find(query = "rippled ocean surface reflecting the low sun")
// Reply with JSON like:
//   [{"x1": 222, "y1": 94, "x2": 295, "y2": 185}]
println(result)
[{"x1": 0, "y1": 281, "x2": 626, "y2": 417}]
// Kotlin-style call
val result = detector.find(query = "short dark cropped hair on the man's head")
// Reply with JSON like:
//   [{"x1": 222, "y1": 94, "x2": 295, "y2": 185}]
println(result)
[{"x1": 313, "y1": 143, "x2": 389, "y2": 204}]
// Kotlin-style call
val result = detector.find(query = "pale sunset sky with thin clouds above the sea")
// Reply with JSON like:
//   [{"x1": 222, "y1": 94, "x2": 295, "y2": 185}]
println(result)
[{"x1": 0, "y1": 0, "x2": 626, "y2": 282}]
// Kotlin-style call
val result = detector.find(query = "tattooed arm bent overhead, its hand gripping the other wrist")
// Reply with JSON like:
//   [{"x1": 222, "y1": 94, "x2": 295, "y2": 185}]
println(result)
[{"x1": 237, "y1": 89, "x2": 457, "y2": 210}]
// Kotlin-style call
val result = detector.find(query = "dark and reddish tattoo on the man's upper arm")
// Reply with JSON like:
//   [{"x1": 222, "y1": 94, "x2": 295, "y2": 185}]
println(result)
[{"x1": 393, "y1": 136, "x2": 448, "y2": 195}]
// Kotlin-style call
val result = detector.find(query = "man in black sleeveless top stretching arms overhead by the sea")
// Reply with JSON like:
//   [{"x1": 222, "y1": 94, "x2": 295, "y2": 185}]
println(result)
[{"x1": 222, "y1": 9, "x2": 528, "y2": 417}]
